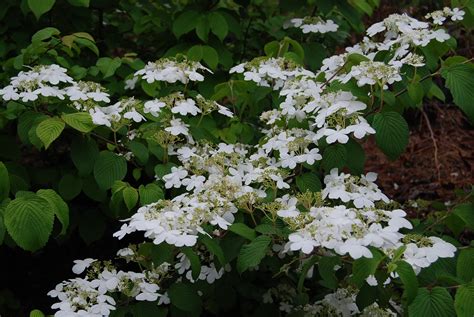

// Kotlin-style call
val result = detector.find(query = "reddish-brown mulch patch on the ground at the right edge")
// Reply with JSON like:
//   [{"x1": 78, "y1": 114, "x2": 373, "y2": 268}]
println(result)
[{"x1": 364, "y1": 104, "x2": 474, "y2": 202}]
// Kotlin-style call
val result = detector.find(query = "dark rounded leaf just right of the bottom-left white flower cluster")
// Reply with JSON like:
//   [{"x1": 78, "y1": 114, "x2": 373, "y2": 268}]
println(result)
[{"x1": 168, "y1": 282, "x2": 202, "y2": 313}]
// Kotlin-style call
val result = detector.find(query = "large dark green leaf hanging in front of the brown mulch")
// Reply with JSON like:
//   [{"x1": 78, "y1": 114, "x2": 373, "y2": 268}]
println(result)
[{"x1": 372, "y1": 111, "x2": 409, "y2": 160}]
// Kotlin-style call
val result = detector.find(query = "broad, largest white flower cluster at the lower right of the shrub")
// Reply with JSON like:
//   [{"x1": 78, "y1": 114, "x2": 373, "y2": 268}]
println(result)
[{"x1": 280, "y1": 198, "x2": 412, "y2": 259}]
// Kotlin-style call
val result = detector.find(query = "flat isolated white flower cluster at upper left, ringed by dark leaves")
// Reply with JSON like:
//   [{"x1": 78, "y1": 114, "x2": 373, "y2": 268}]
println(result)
[{"x1": 129, "y1": 58, "x2": 212, "y2": 84}]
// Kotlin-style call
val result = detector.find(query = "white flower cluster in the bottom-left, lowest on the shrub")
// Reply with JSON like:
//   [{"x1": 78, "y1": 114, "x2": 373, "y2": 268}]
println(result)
[{"x1": 48, "y1": 259, "x2": 169, "y2": 317}]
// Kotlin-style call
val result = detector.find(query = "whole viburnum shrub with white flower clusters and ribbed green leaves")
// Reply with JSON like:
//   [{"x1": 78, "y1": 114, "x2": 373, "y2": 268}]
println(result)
[{"x1": 0, "y1": 2, "x2": 474, "y2": 316}]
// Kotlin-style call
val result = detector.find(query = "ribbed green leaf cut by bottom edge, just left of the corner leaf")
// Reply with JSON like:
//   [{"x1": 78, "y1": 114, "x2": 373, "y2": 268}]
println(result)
[{"x1": 408, "y1": 286, "x2": 456, "y2": 317}]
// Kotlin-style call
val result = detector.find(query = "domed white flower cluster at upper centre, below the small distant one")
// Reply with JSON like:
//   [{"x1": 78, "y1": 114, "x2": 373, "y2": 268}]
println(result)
[{"x1": 229, "y1": 57, "x2": 314, "y2": 90}]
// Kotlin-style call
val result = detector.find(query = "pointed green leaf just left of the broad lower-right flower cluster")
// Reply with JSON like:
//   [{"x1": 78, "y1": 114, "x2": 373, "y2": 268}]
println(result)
[{"x1": 237, "y1": 235, "x2": 272, "y2": 273}]
